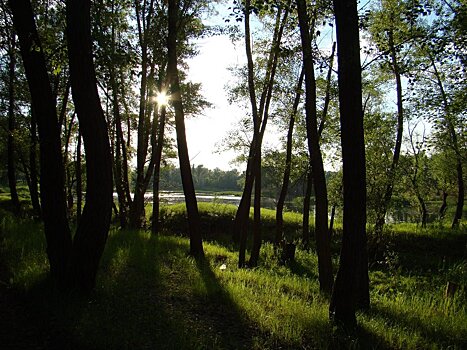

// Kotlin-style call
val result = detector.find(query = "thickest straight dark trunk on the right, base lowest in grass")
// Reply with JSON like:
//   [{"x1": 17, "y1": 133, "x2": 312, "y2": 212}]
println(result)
[{"x1": 329, "y1": 0, "x2": 370, "y2": 326}]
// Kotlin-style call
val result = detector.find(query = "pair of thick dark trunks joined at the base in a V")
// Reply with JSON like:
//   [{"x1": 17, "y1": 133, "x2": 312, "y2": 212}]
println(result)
[{"x1": 9, "y1": 0, "x2": 112, "y2": 292}]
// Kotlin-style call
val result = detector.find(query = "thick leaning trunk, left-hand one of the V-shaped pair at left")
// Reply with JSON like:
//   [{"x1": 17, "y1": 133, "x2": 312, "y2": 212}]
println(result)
[{"x1": 9, "y1": 0, "x2": 72, "y2": 285}]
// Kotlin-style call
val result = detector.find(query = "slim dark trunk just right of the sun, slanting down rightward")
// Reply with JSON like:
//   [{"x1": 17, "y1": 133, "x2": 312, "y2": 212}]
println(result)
[{"x1": 167, "y1": 0, "x2": 204, "y2": 258}]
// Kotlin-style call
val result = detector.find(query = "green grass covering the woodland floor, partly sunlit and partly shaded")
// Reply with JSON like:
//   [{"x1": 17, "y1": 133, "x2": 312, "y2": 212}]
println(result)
[{"x1": 0, "y1": 203, "x2": 467, "y2": 349}]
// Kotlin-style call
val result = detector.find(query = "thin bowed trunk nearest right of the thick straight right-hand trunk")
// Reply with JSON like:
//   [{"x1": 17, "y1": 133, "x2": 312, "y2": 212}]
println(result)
[{"x1": 374, "y1": 31, "x2": 404, "y2": 235}]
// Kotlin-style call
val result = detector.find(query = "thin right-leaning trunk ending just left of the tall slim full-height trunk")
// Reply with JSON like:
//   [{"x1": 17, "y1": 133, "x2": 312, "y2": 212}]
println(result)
[{"x1": 275, "y1": 69, "x2": 305, "y2": 246}]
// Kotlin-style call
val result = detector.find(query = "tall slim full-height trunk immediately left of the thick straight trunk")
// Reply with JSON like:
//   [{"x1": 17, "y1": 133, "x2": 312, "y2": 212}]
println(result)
[{"x1": 297, "y1": 0, "x2": 333, "y2": 294}]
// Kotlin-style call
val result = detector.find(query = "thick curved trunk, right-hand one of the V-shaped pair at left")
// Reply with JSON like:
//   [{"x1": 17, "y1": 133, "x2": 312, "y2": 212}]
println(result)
[{"x1": 66, "y1": 0, "x2": 113, "y2": 292}]
